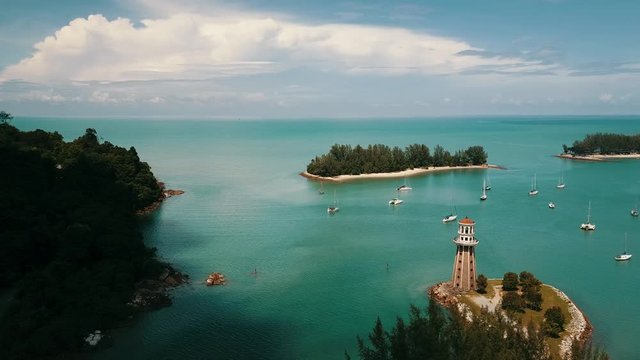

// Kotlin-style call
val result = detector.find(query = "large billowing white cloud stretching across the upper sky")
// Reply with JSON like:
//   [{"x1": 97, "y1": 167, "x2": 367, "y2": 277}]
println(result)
[{"x1": 0, "y1": 12, "x2": 549, "y2": 82}]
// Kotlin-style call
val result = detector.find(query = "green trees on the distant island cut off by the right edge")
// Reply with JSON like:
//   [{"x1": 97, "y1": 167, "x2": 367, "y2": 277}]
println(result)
[{"x1": 562, "y1": 133, "x2": 640, "y2": 155}]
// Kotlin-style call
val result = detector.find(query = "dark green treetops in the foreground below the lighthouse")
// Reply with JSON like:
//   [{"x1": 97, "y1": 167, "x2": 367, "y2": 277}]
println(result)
[{"x1": 356, "y1": 300, "x2": 608, "y2": 360}]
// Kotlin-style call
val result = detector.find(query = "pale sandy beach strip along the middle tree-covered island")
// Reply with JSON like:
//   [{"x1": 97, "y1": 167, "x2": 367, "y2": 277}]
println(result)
[{"x1": 300, "y1": 164, "x2": 505, "y2": 183}]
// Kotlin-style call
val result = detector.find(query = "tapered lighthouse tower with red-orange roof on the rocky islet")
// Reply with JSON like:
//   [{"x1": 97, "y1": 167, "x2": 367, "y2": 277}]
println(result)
[{"x1": 451, "y1": 217, "x2": 478, "y2": 291}]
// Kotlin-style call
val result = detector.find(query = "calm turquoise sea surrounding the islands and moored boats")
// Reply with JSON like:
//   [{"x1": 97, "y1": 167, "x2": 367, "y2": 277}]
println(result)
[{"x1": 13, "y1": 116, "x2": 640, "y2": 359}]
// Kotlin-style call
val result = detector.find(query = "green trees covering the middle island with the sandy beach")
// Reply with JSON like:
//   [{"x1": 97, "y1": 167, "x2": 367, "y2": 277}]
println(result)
[{"x1": 307, "y1": 144, "x2": 487, "y2": 176}]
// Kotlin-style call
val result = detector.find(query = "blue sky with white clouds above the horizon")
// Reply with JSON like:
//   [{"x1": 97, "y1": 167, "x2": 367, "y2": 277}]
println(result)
[{"x1": 0, "y1": 0, "x2": 640, "y2": 119}]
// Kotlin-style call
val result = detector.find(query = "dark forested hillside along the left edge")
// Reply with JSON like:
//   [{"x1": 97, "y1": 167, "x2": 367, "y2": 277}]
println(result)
[{"x1": 0, "y1": 113, "x2": 164, "y2": 359}]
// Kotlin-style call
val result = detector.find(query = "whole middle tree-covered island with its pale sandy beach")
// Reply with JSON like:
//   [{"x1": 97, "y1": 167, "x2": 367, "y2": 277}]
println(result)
[{"x1": 300, "y1": 144, "x2": 500, "y2": 182}]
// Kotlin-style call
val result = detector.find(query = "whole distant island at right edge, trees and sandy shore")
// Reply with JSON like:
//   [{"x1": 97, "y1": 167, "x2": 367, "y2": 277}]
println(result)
[{"x1": 558, "y1": 133, "x2": 640, "y2": 161}]
